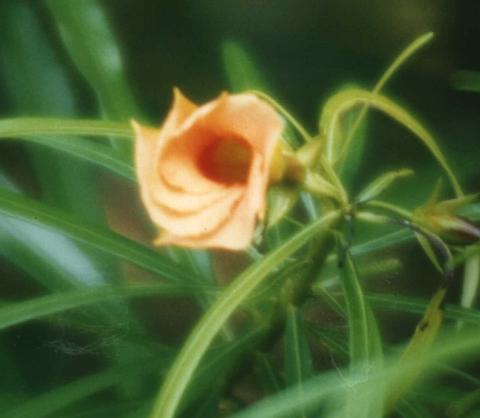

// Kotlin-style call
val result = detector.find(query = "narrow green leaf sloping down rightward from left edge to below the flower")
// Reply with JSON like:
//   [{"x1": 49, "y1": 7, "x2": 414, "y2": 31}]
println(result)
[{"x1": 0, "y1": 190, "x2": 191, "y2": 281}]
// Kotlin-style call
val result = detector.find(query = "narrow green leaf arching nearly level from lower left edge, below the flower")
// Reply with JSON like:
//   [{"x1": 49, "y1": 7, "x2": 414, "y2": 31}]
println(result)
[{"x1": 0, "y1": 283, "x2": 205, "y2": 330}]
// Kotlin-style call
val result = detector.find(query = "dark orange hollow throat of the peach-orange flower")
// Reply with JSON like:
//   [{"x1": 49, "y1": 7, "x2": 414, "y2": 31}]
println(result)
[{"x1": 198, "y1": 138, "x2": 252, "y2": 184}]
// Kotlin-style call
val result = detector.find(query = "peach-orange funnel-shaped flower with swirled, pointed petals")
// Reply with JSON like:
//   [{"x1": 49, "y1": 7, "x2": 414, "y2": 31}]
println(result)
[{"x1": 132, "y1": 89, "x2": 283, "y2": 250}]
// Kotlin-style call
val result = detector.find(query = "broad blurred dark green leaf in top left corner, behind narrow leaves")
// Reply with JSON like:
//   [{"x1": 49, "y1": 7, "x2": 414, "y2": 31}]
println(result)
[{"x1": 0, "y1": 2, "x2": 103, "y2": 212}]
